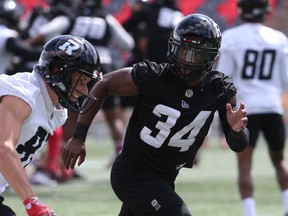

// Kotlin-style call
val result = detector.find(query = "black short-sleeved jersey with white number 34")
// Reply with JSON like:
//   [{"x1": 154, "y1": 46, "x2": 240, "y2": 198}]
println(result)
[{"x1": 122, "y1": 61, "x2": 236, "y2": 179}]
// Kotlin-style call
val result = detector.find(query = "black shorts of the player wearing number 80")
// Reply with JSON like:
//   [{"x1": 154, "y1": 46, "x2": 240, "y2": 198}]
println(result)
[{"x1": 247, "y1": 113, "x2": 286, "y2": 151}]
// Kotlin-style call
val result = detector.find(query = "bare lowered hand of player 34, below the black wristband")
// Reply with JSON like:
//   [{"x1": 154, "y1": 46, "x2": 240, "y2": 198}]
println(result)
[{"x1": 62, "y1": 137, "x2": 86, "y2": 169}]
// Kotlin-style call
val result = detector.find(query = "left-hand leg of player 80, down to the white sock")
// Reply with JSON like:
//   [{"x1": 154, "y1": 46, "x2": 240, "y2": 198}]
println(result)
[{"x1": 237, "y1": 115, "x2": 260, "y2": 216}]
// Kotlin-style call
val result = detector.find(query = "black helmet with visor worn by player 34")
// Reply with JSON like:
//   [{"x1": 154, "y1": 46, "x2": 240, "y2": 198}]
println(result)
[{"x1": 167, "y1": 14, "x2": 221, "y2": 81}]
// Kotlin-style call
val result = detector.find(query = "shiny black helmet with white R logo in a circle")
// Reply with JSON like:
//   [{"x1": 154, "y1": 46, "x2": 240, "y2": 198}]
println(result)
[{"x1": 34, "y1": 35, "x2": 102, "y2": 113}]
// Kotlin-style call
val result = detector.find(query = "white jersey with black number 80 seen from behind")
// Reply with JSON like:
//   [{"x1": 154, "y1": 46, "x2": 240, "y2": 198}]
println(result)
[{"x1": 217, "y1": 23, "x2": 288, "y2": 115}]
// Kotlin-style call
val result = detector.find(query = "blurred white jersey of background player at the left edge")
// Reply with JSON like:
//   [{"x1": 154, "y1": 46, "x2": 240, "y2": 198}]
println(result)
[{"x1": 0, "y1": 25, "x2": 19, "y2": 74}]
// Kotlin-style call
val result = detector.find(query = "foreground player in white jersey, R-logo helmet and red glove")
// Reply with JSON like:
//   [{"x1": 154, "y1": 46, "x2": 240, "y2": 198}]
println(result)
[{"x1": 0, "y1": 35, "x2": 101, "y2": 216}]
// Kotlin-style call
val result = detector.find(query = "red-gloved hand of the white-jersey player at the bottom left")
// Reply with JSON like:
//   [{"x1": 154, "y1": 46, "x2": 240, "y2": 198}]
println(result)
[{"x1": 23, "y1": 196, "x2": 56, "y2": 216}]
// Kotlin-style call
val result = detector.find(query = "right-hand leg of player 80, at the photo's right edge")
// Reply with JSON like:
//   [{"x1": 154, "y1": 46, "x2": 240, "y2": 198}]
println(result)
[{"x1": 263, "y1": 114, "x2": 288, "y2": 214}]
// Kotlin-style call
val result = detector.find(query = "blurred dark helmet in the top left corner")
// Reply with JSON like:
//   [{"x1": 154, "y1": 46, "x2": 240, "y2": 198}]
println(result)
[{"x1": 0, "y1": 0, "x2": 23, "y2": 30}]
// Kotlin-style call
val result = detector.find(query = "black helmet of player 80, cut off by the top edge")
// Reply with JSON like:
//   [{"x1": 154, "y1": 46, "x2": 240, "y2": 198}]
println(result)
[{"x1": 237, "y1": 0, "x2": 270, "y2": 22}]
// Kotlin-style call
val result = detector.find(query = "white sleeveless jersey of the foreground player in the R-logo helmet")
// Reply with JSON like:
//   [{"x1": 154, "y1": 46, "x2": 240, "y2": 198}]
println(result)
[{"x1": 0, "y1": 72, "x2": 67, "y2": 192}]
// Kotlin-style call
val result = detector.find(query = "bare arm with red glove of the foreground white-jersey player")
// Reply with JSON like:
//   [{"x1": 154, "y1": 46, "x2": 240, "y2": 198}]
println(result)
[{"x1": 0, "y1": 96, "x2": 55, "y2": 216}]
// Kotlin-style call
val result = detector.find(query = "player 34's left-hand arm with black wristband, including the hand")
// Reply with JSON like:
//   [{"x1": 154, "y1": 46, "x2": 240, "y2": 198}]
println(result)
[{"x1": 62, "y1": 67, "x2": 139, "y2": 169}]
